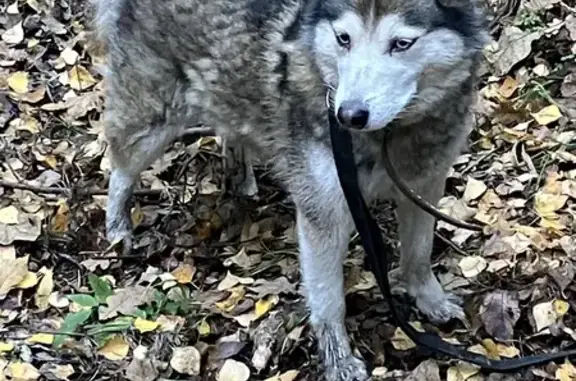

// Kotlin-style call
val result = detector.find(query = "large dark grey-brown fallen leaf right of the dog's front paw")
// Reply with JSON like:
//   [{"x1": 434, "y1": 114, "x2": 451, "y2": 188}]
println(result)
[{"x1": 479, "y1": 290, "x2": 520, "y2": 340}]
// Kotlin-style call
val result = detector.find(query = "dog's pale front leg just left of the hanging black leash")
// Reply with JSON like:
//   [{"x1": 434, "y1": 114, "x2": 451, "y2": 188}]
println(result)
[{"x1": 290, "y1": 143, "x2": 368, "y2": 381}]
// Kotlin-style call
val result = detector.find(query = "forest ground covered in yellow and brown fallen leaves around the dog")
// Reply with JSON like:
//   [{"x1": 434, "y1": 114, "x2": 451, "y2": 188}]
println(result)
[{"x1": 0, "y1": 0, "x2": 576, "y2": 381}]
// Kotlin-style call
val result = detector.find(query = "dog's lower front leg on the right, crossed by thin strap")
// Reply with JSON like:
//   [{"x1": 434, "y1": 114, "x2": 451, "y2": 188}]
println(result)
[{"x1": 398, "y1": 176, "x2": 464, "y2": 323}]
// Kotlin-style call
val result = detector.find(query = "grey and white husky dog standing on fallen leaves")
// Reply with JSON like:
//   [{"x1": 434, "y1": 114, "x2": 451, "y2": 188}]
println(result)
[{"x1": 95, "y1": 0, "x2": 487, "y2": 381}]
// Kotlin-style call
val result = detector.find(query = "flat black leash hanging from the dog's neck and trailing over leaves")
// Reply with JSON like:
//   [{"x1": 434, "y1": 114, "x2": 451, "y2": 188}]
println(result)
[{"x1": 328, "y1": 111, "x2": 576, "y2": 372}]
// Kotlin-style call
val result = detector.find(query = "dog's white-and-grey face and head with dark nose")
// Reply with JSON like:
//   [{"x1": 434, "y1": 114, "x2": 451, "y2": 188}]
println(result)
[{"x1": 309, "y1": 0, "x2": 488, "y2": 130}]
